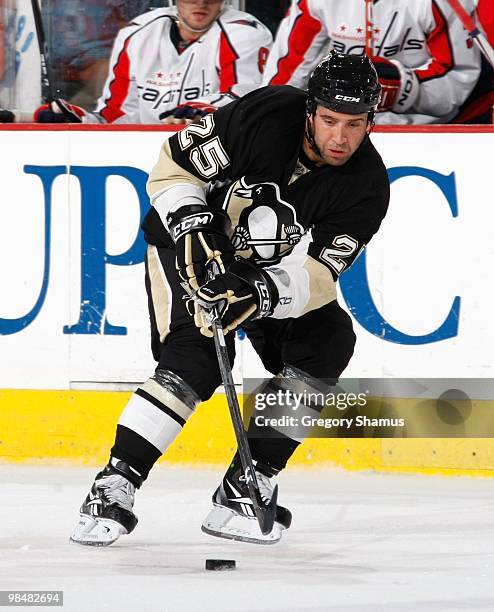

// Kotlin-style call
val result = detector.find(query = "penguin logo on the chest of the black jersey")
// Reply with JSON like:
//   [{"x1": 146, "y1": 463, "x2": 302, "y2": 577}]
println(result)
[{"x1": 223, "y1": 178, "x2": 304, "y2": 262}]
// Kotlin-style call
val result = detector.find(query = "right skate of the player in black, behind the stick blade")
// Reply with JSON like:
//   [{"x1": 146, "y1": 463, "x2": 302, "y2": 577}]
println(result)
[{"x1": 201, "y1": 455, "x2": 292, "y2": 544}]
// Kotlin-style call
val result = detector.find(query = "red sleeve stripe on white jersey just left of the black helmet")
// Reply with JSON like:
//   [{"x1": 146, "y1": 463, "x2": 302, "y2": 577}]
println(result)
[{"x1": 269, "y1": 0, "x2": 322, "y2": 85}]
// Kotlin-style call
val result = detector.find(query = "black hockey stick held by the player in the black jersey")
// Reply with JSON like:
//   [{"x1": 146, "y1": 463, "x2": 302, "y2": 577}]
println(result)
[{"x1": 182, "y1": 262, "x2": 278, "y2": 535}]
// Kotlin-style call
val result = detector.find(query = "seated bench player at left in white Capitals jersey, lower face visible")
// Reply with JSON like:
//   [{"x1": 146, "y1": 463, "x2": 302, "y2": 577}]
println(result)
[{"x1": 35, "y1": 0, "x2": 272, "y2": 123}]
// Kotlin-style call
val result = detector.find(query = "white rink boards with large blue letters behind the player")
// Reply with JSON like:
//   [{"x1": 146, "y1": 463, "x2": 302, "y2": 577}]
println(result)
[{"x1": 0, "y1": 128, "x2": 494, "y2": 389}]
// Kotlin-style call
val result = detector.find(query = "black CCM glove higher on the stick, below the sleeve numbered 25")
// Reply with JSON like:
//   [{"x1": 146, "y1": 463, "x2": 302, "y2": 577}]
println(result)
[{"x1": 167, "y1": 204, "x2": 234, "y2": 291}]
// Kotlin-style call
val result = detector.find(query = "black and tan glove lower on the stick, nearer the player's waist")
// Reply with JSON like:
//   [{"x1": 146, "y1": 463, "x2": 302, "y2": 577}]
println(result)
[{"x1": 194, "y1": 260, "x2": 278, "y2": 337}]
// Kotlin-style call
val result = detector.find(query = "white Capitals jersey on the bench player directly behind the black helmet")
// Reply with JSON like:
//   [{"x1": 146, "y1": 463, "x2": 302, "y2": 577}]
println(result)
[{"x1": 263, "y1": 0, "x2": 482, "y2": 123}]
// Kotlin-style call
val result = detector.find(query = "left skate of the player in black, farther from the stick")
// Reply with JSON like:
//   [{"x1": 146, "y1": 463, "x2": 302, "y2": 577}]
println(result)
[{"x1": 70, "y1": 458, "x2": 142, "y2": 546}]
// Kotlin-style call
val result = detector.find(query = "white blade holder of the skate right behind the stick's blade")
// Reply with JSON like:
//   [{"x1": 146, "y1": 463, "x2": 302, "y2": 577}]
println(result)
[{"x1": 201, "y1": 506, "x2": 283, "y2": 544}]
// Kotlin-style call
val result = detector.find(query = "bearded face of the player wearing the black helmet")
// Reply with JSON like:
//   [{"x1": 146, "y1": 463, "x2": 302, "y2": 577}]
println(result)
[{"x1": 311, "y1": 106, "x2": 368, "y2": 166}]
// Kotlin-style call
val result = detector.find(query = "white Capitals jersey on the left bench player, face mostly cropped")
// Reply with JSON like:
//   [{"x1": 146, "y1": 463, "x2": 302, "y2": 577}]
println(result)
[{"x1": 90, "y1": 8, "x2": 273, "y2": 123}]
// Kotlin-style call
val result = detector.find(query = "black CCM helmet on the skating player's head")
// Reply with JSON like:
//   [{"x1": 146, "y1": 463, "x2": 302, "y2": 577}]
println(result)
[{"x1": 307, "y1": 51, "x2": 381, "y2": 115}]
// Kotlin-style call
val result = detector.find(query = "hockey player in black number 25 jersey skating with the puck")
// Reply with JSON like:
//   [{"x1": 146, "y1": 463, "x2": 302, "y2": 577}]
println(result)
[{"x1": 72, "y1": 52, "x2": 389, "y2": 545}]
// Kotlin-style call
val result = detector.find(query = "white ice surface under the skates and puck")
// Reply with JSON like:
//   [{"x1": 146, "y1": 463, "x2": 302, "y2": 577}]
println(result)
[{"x1": 0, "y1": 465, "x2": 494, "y2": 612}]
